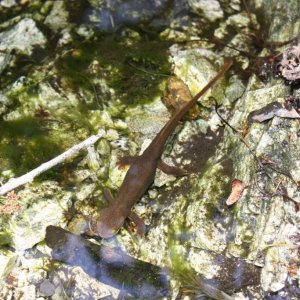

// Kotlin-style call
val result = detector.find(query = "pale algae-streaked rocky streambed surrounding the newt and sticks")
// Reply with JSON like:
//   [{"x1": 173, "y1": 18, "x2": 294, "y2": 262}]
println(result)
[{"x1": 0, "y1": 0, "x2": 300, "y2": 300}]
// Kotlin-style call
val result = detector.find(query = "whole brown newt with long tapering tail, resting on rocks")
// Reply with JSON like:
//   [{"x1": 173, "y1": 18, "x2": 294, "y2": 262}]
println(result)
[{"x1": 96, "y1": 60, "x2": 232, "y2": 238}]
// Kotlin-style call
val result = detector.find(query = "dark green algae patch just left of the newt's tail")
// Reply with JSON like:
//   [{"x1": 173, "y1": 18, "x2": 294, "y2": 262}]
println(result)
[{"x1": 56, "y1": 35, "x2": 170, "y2": 105}]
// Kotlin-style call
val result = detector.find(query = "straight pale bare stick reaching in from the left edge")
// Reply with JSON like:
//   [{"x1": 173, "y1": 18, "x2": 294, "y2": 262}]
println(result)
[{"x1": 0, "y1": 129, "x2": 105, "y2": 195}]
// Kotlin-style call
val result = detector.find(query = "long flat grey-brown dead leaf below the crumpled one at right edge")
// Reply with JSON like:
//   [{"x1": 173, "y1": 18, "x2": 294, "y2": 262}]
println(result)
[{"x1": 247, "y1": 102, "x2": 300, "y2": 123}]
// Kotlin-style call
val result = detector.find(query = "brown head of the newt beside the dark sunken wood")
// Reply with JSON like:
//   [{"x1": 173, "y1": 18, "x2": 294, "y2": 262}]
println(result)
[{"x1": 96, "y1": 207, "x2": 125, "y2": 239}]
